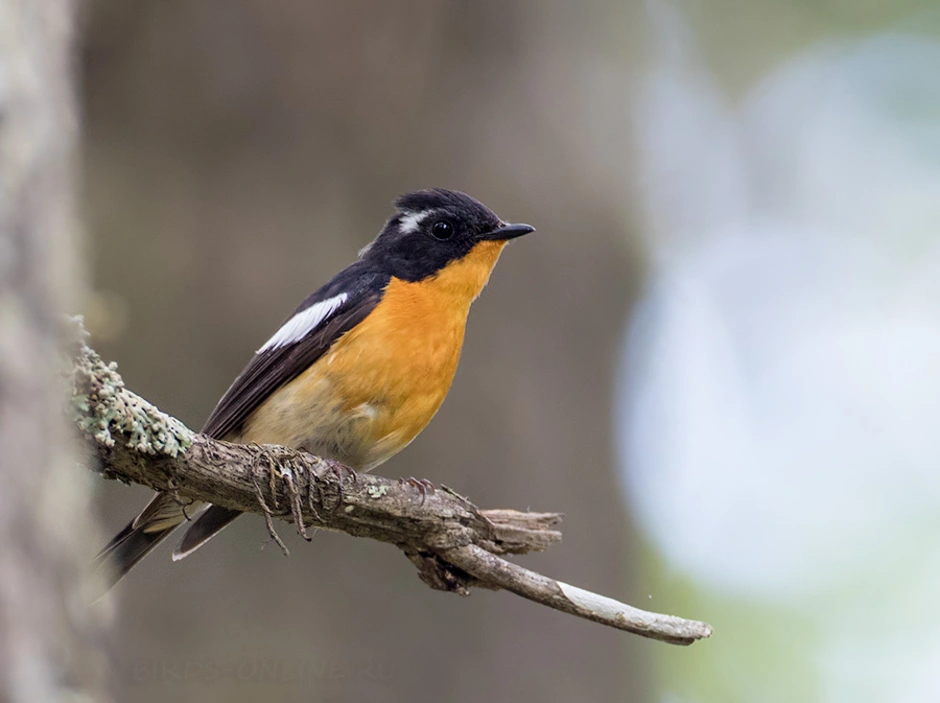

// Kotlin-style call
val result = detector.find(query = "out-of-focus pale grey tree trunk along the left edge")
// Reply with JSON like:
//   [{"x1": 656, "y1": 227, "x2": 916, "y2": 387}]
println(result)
[{"x1": 0, "y1": 0, "x2": 103, "y2": 703}]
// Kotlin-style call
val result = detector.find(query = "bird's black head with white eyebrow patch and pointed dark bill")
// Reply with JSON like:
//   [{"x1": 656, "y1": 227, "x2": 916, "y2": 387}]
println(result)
[{"x1": 360, "y1": 188, "x2": 535, "y2": 281}]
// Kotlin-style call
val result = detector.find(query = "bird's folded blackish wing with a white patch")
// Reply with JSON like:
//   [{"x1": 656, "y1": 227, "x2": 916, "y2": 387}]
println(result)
[{"x1": 202, "y1": 261, "x2": 388, "y2": 439}]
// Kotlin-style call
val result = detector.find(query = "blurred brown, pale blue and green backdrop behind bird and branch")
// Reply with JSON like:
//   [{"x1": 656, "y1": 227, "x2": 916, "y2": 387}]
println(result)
[{"x1": 80, "y1": 0, "x2": 940, "y2": 703}]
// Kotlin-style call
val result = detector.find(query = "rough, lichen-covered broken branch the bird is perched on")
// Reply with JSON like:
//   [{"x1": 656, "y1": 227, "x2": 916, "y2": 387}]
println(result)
[{"x1": 71, "y1": 322, "x2": 712, "y2": 644}]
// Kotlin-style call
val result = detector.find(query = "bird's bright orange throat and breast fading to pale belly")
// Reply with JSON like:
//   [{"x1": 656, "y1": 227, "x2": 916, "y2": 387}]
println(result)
[{"x1": 241, "y1": 242, "x2": 504, "y2": 469}]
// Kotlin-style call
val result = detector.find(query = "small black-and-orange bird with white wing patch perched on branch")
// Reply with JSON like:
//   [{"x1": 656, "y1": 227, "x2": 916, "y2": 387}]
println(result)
[{"x1": 95, "y1": 188, "x2": 535, "y2": 588}]
